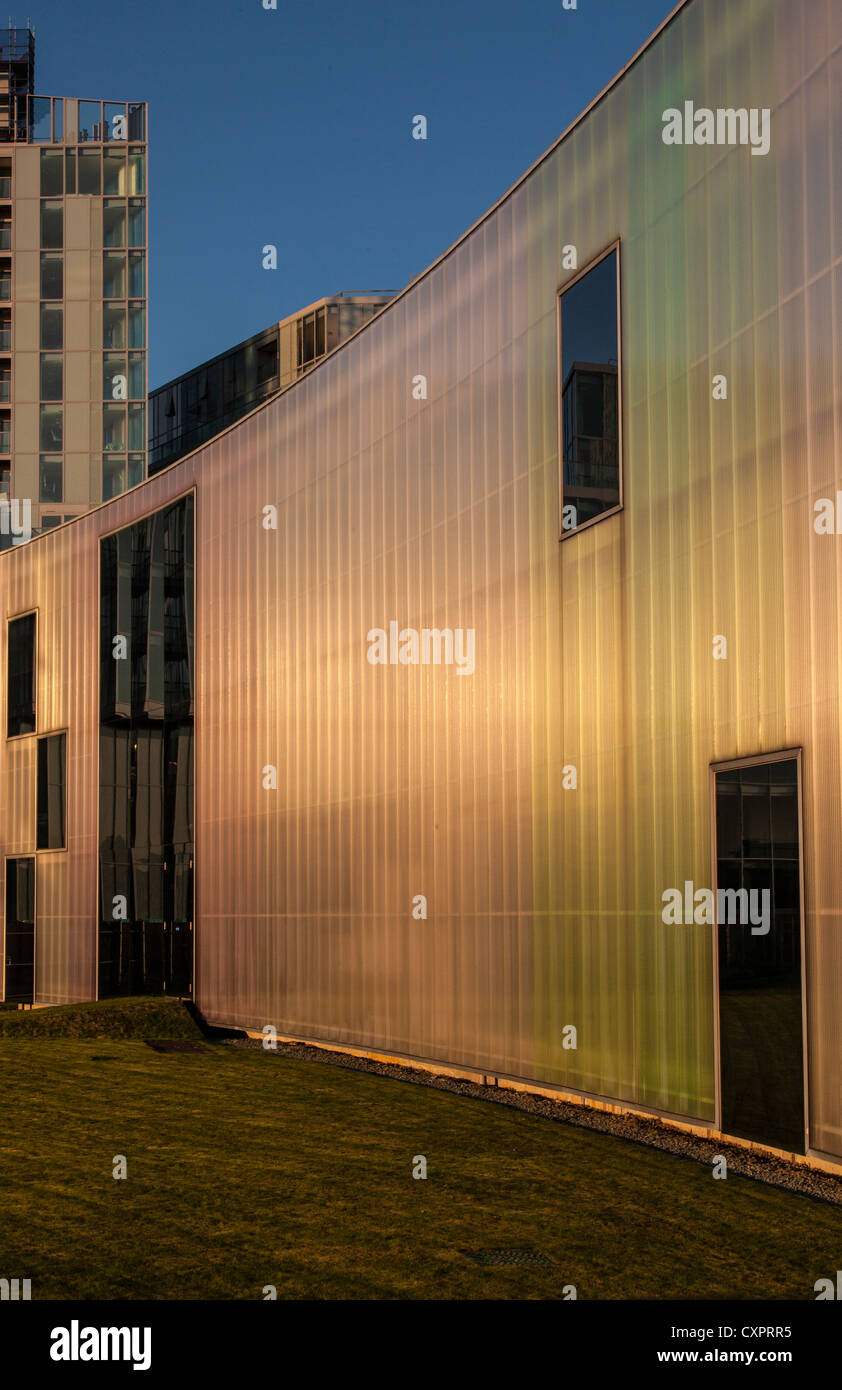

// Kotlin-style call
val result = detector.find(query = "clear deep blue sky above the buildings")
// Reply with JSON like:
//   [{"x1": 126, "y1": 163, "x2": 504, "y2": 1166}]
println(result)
[{"x1": 28, "y1": 0, "x2": 674, "y2": 386}]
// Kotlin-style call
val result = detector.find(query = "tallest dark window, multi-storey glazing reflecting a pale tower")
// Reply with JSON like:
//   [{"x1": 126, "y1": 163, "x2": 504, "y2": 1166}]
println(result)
[{"x1": 100, "y1": 498, "x2": 193, "y2": 995}]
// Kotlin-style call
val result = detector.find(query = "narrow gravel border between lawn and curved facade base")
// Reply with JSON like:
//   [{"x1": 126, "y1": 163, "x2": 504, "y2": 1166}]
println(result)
[{"x1": 218, "y1": 1037, "x2": 842, "y2": 1207}]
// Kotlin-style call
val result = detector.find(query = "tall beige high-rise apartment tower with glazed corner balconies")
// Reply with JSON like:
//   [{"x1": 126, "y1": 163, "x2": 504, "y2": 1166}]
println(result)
[{"x1": 0, "y1": 28, "x2": 147, "y2": 548}]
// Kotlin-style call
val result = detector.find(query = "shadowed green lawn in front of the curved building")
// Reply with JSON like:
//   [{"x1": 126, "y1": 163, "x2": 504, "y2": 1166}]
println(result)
[{"x1": 0, "y1": 1005, "x2": 842, "y2": 1300}]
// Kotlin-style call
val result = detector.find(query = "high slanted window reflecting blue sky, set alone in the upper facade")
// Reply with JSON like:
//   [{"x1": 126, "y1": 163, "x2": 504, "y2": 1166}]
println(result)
[{"x1": 559, "y1": 246, "x2": 621, "y2": 539}]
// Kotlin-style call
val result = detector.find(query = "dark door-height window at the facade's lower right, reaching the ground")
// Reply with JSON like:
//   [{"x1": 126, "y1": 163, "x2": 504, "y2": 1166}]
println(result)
[{"x1": 716, "y1": 759, "x2": 804, "y2": 1154}]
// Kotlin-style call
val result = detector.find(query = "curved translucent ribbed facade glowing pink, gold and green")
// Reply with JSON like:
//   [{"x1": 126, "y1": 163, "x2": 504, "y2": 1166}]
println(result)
[{"x1": 0, "y1": 0, "x2": 842, "y2": 1159}]
